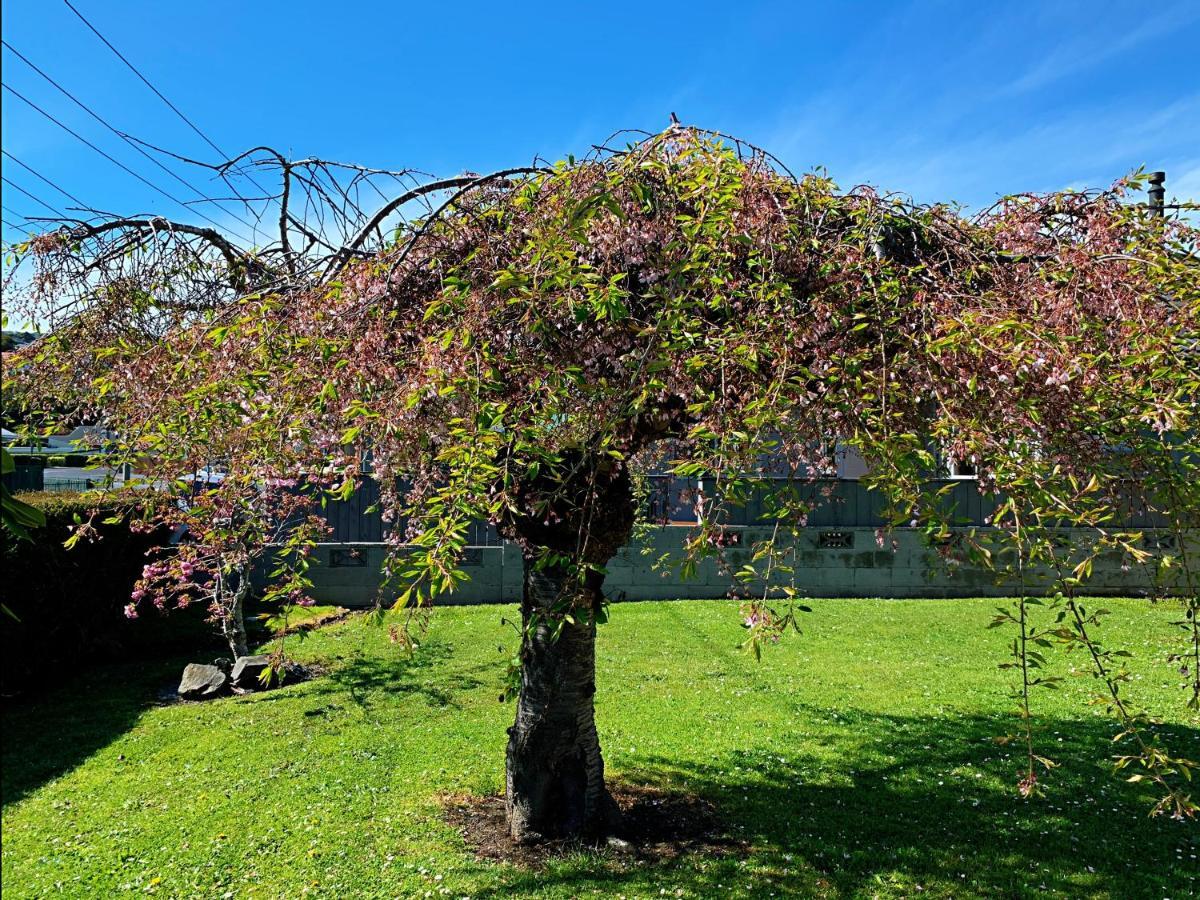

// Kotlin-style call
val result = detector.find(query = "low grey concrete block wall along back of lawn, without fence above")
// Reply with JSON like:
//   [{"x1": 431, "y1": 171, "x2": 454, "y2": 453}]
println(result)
[{"x1": 280, "y1": 526, "x2": 1200, "y2": 607}]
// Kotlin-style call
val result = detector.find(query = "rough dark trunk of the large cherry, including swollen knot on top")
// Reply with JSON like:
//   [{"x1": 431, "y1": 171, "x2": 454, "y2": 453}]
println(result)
[{"x1": 505, "y1": 466, "x2": 634, "y2": 844}]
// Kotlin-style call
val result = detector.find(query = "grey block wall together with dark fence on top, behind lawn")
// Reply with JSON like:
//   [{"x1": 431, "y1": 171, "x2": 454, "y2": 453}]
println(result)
[{"x1": 255, "y1": 475, "x2": 1200, "y2": 606}]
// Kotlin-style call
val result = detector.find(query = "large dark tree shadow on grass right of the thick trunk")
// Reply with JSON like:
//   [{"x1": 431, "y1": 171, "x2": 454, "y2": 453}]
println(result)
[{"x1": 463, "y1": 713, "x2": 1200, "y2": 898}]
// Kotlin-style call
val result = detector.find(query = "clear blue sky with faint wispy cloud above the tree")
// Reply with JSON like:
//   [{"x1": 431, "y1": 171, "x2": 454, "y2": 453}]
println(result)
[{"x1": 2, "y1": 0, "x2": 1200, "y2": 247}]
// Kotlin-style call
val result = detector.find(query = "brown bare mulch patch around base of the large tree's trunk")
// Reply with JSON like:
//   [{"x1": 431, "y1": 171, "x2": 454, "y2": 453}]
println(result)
[{"x1": 444, "y1": 782, "x2": 746, "y2": 869}]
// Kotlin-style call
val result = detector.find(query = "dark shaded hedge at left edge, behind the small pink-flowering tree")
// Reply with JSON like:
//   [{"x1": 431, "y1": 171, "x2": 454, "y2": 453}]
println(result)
[{"x1": 0, "y1": 493, "x2": 220, "y2": 696}]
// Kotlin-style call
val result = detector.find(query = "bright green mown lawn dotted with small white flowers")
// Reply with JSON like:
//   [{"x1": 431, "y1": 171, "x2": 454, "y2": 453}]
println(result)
[{"x1": 2, "y1": 600, "x2": 1200, "y2": 900}]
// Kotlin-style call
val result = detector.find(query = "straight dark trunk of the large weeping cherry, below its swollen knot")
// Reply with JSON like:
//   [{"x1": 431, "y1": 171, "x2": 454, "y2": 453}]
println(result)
[{"x1": 506, "y1": 564, "x2": 619, "y2": 844}]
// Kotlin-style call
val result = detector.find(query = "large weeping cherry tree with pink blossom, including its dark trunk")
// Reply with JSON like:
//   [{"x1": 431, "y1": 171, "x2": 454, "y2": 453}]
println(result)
[{"x1": 7, "y1": 126, "x2": 1200, "y2": 841}]
